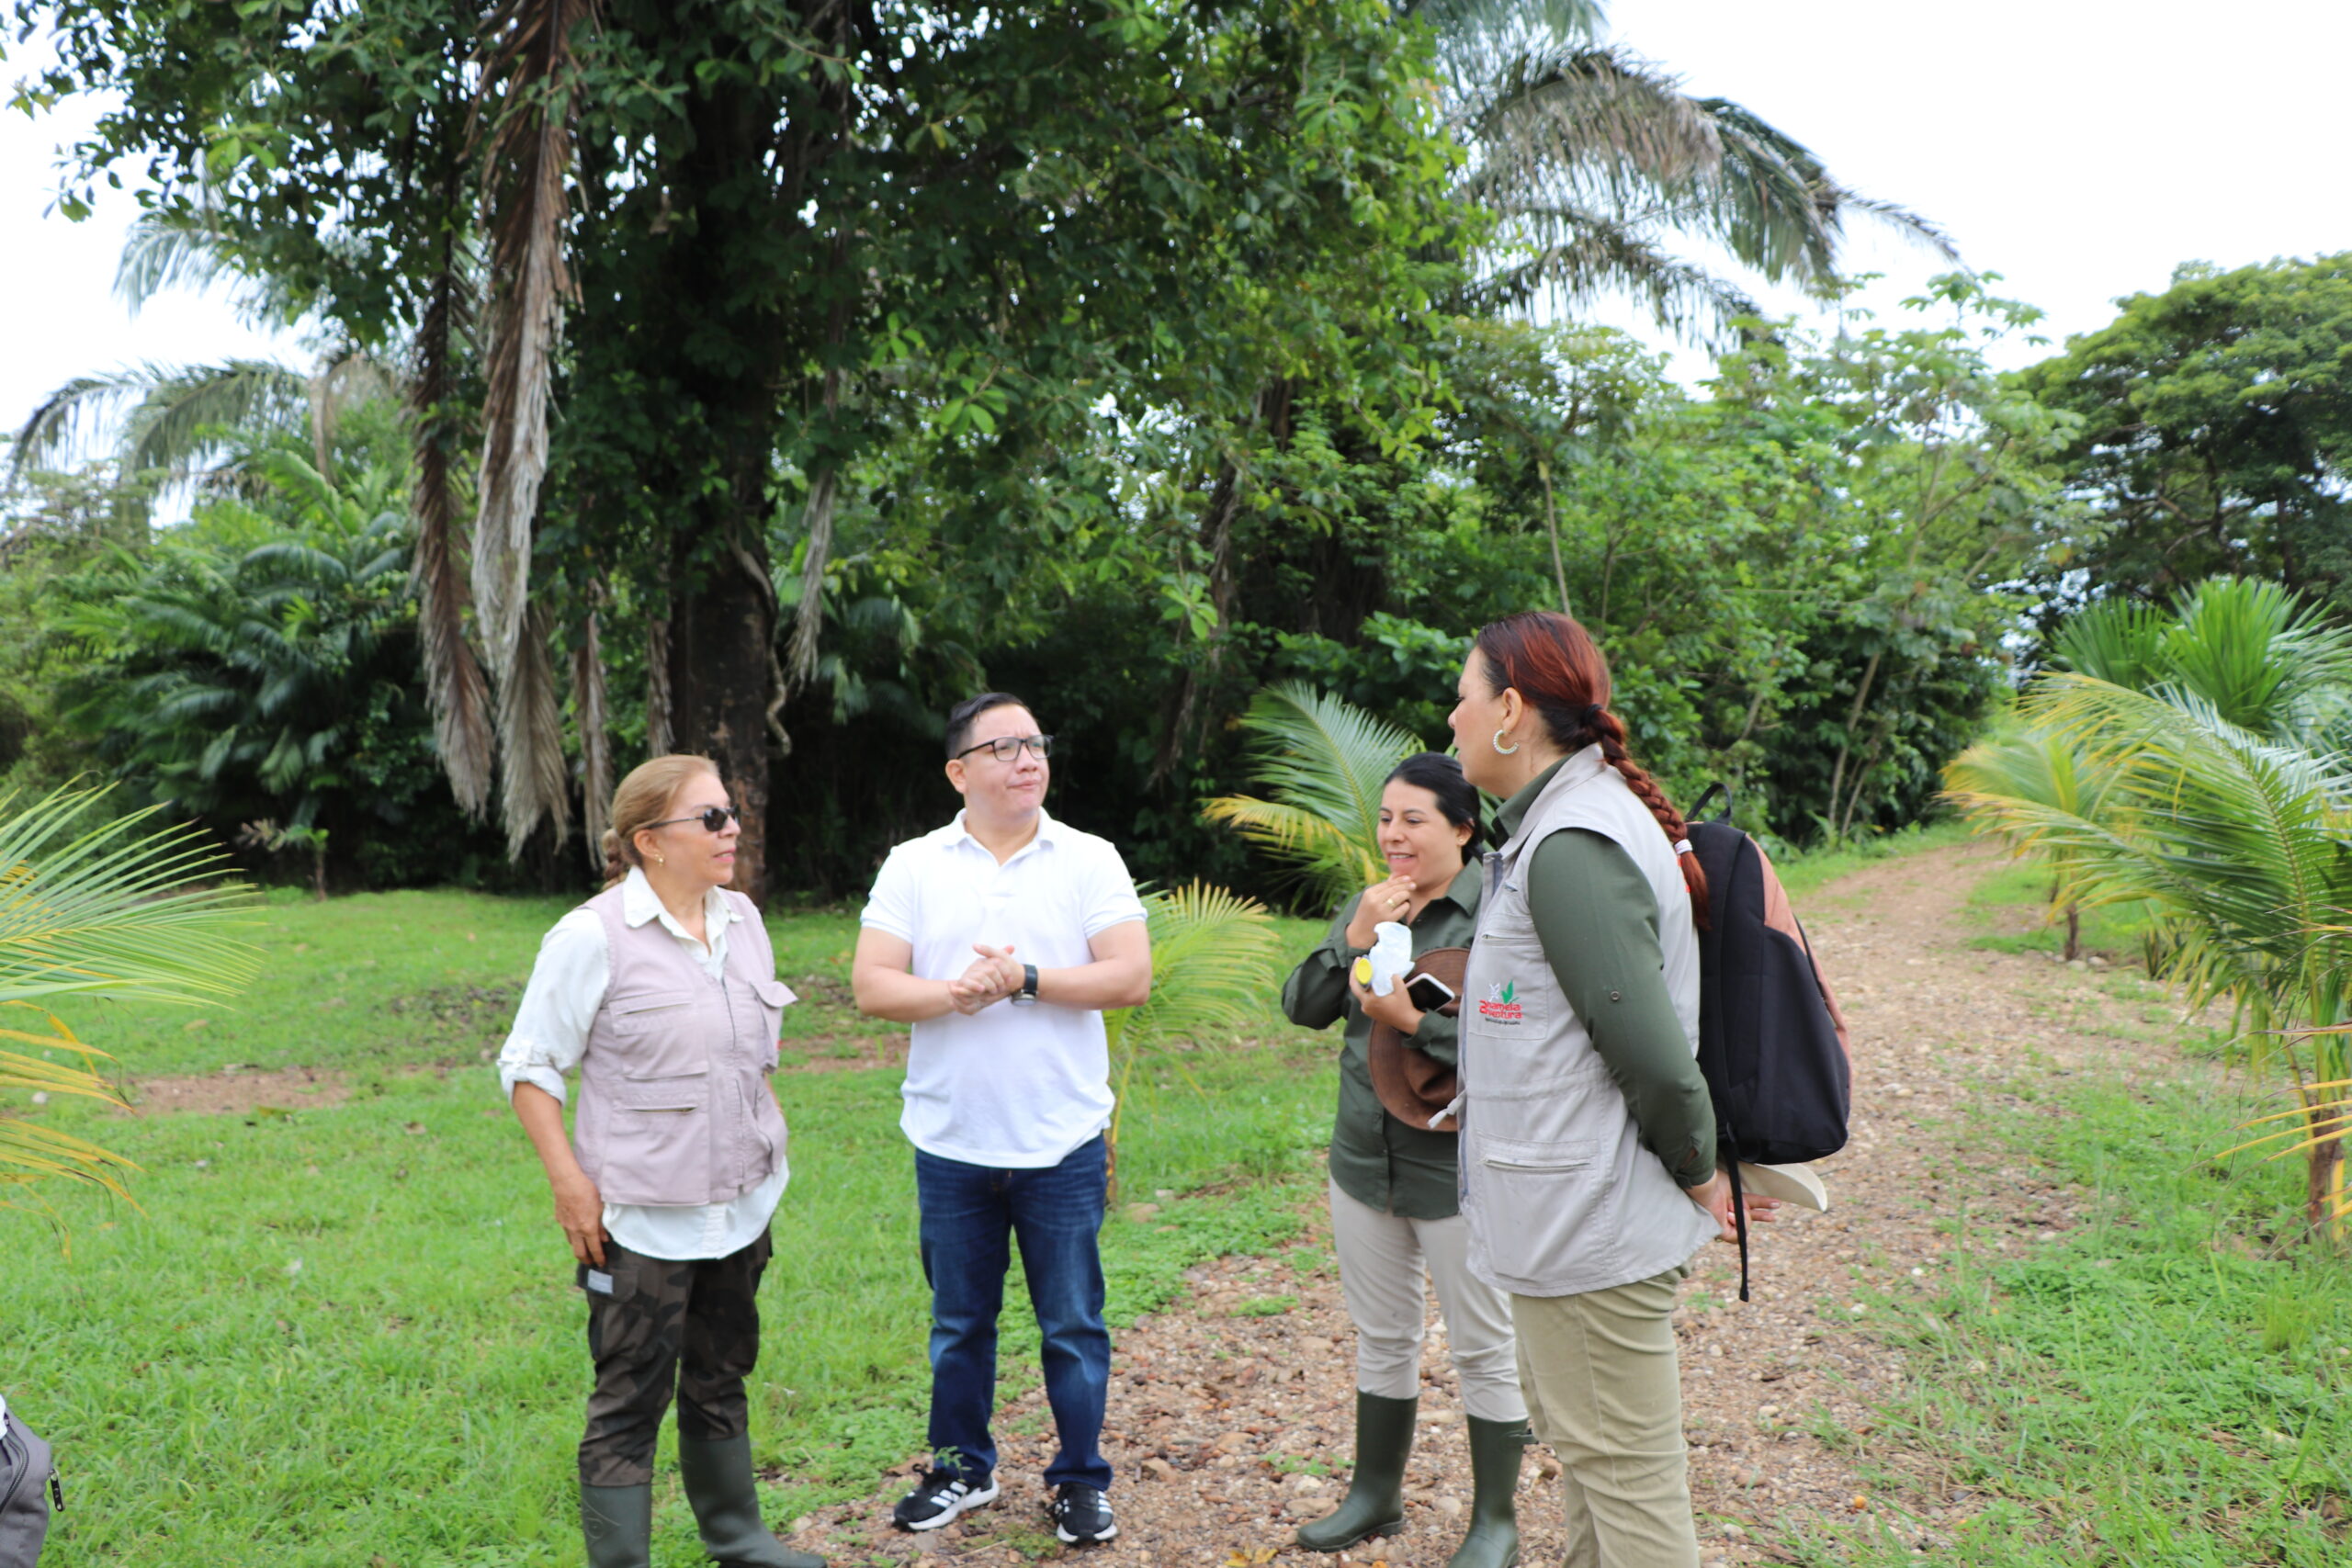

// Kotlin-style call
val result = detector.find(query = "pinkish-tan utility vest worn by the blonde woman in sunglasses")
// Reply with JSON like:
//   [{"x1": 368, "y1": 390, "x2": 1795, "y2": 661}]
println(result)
[{"x1": 571, "y1": 888, "x2": 790, "y2": 1206}]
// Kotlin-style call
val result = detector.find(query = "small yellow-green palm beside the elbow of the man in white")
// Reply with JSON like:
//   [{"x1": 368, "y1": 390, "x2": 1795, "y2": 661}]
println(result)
[{"x1": 1103, "y1": 882, "x2": 1282, "y2": 1175}]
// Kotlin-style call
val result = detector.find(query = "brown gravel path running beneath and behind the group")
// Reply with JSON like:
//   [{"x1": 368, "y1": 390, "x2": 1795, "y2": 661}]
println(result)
[{"x1": 793, "y1": 846, "x2": 2129, "y2": 1568}]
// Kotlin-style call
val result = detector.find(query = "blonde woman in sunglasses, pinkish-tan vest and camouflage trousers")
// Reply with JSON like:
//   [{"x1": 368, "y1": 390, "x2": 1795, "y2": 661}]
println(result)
[{"x1": 499, "y1": 757, "x2": 823, "y2": 1568}]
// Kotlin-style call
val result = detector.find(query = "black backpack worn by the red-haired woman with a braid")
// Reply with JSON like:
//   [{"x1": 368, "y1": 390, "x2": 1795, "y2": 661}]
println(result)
[{"x1": 1689, "y1": 785, "x2": 1853, "y2": 1300}]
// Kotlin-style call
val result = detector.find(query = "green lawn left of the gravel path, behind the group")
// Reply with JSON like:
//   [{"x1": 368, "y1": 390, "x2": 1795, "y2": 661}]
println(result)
[{"x1": 0, "y1": 894, "x2": 1336, "y2": 1568}]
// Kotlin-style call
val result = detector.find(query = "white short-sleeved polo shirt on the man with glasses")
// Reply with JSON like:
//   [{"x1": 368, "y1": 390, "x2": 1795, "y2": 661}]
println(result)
[{"x1": 858, "y1": 811, "x2": 1143, "y2": 1170}]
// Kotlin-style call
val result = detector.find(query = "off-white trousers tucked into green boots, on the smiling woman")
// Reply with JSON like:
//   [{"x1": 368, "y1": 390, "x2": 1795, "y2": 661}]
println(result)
[{"x1": 1331, "y1": 1182, "x2": 1526, "y2": 1420}]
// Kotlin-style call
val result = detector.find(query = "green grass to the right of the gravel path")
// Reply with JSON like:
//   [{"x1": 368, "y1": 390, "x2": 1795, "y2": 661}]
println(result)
[{"x1": 1782, "y1": 872, "x2": 2352, "y2": 1568}]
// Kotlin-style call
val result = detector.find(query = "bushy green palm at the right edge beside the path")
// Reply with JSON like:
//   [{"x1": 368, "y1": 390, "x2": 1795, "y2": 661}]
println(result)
[{"x1": 1945, "y1": 581, "x2": 2352, "y2": 1236}]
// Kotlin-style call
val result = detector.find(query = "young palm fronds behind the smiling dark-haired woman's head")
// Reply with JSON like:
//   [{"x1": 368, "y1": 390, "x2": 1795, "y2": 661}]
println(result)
[{"x1": 1202, "y1": 682, "x2": 1420, "y2": 908}]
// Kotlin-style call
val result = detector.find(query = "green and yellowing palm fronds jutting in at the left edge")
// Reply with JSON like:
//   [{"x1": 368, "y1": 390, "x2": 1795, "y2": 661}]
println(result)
[{"x1": 0, "y1": 785, "x2": 256, "y2": 1203}]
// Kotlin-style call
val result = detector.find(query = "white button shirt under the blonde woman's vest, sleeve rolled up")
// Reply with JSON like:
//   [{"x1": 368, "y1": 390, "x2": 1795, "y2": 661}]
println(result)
[{"x1": 499, "y1": 867, "x2": 793, "y2": 1260}]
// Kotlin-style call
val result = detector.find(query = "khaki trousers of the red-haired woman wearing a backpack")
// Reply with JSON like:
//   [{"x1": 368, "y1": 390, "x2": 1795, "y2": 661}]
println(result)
[{"x1": 1510, "y1": 1265, "x2": 1698, "y2": 1568}]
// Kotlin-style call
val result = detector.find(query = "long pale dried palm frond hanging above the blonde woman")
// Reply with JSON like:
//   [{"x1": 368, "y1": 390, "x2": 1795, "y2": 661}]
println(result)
[{"x1": 473, "y1": 0, "x2": 588, "y2": 677}]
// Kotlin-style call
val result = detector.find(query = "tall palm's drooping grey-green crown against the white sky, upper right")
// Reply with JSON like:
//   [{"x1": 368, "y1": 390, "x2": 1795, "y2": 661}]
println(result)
[{"x1": 1399, "y1": 0, "x2": 1957, "y2": 336}]
